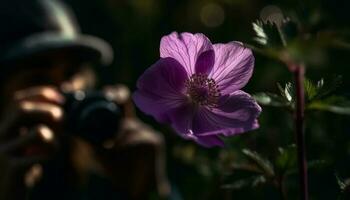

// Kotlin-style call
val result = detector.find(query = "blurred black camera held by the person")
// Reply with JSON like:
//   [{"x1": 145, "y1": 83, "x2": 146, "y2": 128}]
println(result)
[{"x1": 64, "y1": 91, "x2": 121, "y2": 145}]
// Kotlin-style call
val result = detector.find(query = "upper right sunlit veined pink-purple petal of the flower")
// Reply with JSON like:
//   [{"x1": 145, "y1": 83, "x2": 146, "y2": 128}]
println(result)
[{"x1": 209, "y1": 42, "x2": 254, "y2": 94}]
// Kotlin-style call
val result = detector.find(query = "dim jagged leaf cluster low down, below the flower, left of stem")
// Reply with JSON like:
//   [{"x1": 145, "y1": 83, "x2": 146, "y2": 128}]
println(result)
[{"x1": 223, "y1": 144, "x2": 325, "y2": 189}]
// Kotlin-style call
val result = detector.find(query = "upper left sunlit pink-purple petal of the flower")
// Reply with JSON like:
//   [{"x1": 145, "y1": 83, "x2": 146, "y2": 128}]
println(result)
[{"x1": 160, "y1": 32, "x2": 213, "y2": 75}]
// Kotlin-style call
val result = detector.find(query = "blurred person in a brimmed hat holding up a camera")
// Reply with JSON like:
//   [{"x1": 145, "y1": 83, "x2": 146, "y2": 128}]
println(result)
[{"x1": 0, "y1": 0, "x2": 169, "y2": 200}]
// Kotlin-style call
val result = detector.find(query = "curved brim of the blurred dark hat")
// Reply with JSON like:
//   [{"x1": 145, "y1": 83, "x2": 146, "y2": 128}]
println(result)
[{"x1": 0, "y1": 33, "x2": 113, "y2": 65}]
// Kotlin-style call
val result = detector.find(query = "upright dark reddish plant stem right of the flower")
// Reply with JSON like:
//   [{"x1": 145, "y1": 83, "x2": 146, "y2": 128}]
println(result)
[{"x1": 289, "y1": 64, "x2": 309, "y2": 200}]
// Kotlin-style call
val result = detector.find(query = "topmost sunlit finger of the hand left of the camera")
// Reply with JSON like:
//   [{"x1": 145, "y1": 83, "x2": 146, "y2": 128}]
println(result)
[{"x1": 14, "y1": 86, "x2": 65, "y2": 105}]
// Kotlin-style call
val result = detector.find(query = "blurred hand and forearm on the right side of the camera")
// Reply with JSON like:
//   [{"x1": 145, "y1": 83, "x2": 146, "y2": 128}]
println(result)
[{"x1": 99, "y1": 85, "x2": 170, "y2": 199}]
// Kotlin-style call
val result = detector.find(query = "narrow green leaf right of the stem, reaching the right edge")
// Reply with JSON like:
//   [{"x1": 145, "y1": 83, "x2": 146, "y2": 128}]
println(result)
[{"x1": 307, "y1": 96, "x2": 350, "y2": 115}]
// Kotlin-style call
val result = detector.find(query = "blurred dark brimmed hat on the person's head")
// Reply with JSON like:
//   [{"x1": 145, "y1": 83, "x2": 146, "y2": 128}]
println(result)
[{"x1": 0, "y1": 0, "x2": 113, "y2": 65}]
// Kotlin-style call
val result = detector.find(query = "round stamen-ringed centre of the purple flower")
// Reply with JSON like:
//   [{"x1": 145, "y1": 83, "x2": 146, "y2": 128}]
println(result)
[{"x1": 185, "y1": 74, "x2": 221, "y2": 107}]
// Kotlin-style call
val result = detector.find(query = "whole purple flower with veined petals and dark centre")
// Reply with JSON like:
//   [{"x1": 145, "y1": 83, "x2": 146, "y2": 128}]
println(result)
[{"x1": 133, "y1": 32, "x2": 261, "y2": 147}]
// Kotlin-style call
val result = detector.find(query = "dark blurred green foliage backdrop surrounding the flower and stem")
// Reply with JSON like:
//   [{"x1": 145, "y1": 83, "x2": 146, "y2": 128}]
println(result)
[{"x1": 66, "y1": 0, "x2": 350, "y2": 200}]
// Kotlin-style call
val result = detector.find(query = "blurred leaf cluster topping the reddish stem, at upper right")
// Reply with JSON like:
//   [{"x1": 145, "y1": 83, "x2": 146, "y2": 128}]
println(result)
[{"x1": 252, "y1": 18, "x2": 350, "y2": 65}]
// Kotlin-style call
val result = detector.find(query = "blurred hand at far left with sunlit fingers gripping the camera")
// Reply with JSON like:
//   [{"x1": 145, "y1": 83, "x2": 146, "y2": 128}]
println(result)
[{"x1": 0, "y1": 86, "x2": 64, "y2": 199}]
